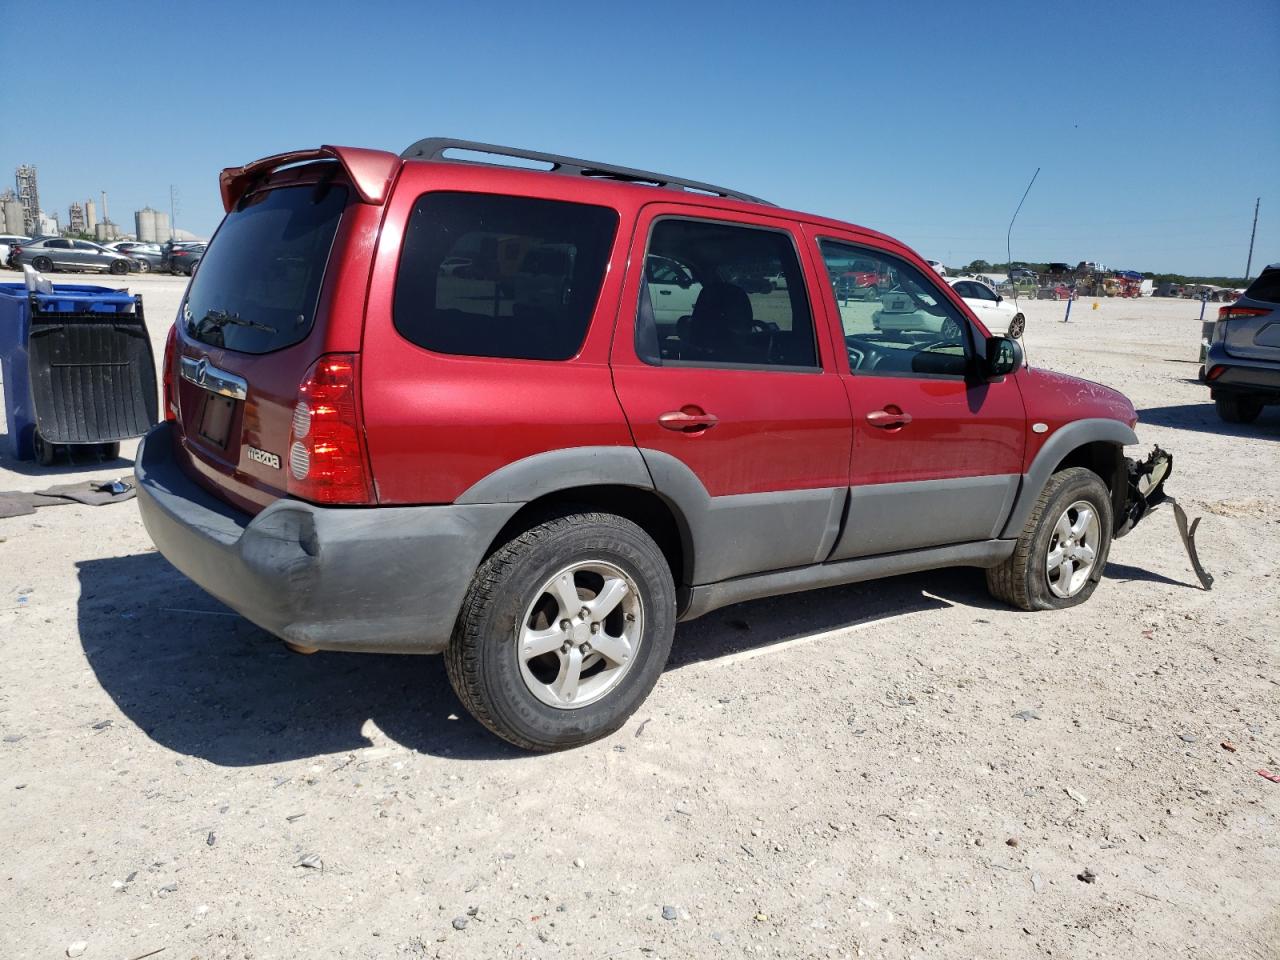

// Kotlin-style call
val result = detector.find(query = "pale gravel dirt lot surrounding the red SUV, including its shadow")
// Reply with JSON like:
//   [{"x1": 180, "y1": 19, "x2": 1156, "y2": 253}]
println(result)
[{"x1": 0, "y1": 275, "x2": 1280, "y2": 960}]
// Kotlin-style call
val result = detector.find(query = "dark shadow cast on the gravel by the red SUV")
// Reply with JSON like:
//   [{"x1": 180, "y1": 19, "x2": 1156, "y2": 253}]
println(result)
[{"x1": 77, "y1": 553, "x2": 998, "y2": 767}]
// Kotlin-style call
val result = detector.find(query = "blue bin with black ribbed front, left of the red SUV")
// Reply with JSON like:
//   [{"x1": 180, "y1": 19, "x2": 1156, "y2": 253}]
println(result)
[{"x1": 0, "y1": 283, "x2": 156, "y2": 463}]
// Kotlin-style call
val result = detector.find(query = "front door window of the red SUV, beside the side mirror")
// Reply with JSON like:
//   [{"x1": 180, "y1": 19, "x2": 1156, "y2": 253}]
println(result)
[{"x1": 820, "y1": 241, "x2": 972, "y2": 376}]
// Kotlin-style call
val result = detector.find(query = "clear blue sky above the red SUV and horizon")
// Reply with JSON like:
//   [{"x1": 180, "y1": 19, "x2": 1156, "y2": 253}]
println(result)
[{"x1": 0, "y1": 0, "x2": 1280, "y2": 275}]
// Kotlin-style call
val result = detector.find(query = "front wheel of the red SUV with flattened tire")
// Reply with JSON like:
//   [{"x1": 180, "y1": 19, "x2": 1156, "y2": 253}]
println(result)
[{"x1": 987, "y1": 467, "x2": 1115, "y2": 611}]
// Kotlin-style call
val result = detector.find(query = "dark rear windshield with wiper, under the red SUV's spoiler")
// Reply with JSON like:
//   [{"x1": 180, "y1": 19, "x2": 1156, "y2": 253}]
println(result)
[{"x1": 183, "y1": 183, "x2": 347, "y2": 353}]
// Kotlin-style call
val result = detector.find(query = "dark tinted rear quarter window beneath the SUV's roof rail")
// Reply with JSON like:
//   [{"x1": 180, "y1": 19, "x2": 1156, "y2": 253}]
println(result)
[{"x1": 394, "y1": 192, "x2": 618, "y2": 360}]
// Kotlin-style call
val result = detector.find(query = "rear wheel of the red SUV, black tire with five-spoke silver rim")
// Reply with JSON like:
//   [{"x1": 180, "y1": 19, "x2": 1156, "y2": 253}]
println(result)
[{"x1": 444, "y1": 512, "x2": 676, "y2": 751}]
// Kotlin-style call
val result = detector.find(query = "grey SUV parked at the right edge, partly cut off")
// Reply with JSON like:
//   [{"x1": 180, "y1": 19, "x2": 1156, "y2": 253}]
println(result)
[{"x1": 1204, "y1": 264, "x2": 1280, "y2": 424}]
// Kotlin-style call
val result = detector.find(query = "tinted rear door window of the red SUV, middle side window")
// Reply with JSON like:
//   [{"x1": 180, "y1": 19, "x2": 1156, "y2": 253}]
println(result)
[{"x1": 636, "y1": 219, "x2": 818, "y2": 369}]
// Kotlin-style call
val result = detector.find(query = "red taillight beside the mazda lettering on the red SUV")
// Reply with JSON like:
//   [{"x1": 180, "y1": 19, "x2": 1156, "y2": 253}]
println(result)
[{"x1": 288, "y1": 353, "x2": 374, "y2": 503}]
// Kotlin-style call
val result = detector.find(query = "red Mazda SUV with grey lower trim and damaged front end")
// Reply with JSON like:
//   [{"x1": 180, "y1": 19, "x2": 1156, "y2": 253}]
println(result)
[{"x1": 136, "y1": 140, "x2": 1170, "y2": 750}]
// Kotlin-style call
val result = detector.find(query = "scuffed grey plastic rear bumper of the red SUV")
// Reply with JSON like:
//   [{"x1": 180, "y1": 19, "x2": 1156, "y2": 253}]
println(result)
[{"x1": 134, "y1": 424, "x2": 521, "y2": 653}]
